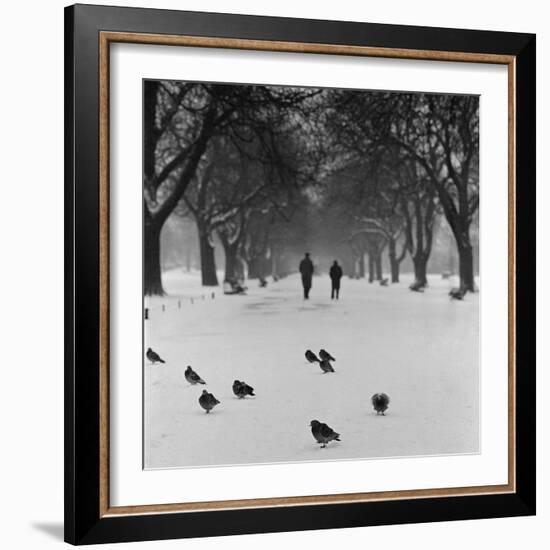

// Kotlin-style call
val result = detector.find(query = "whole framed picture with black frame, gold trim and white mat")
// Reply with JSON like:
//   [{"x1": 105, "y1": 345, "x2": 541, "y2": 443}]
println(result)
[{"x1": 65, "y1": 5, "x2": 536, "y2": 544}]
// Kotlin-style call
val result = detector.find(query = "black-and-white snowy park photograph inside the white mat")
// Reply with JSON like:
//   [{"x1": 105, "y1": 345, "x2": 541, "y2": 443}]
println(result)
[{"x1": 143, "y1": 79, "x2": 480, "y2": 469}]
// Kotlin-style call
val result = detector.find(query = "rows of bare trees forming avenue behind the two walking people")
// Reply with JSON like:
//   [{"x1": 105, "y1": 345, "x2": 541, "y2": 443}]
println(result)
[{"x1": 143, "y1": 81, "x2": 479, "y2": 295}]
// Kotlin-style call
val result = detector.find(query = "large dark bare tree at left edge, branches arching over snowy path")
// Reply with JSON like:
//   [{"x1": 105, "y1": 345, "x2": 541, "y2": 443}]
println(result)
[{"x1": 143, "y1": 81, "x2": 315, "y2": 295}]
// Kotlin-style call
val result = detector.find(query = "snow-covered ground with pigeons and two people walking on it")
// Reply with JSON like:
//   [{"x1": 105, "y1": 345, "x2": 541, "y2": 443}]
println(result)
[{"x1": 144, "y1": 270, "x2": 479, "y2": 468}]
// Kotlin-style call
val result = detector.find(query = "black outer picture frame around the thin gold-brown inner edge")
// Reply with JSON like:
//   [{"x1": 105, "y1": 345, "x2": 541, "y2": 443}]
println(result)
[{"x1": 65, "y1": 5, "x2": 536, "y2": 544}]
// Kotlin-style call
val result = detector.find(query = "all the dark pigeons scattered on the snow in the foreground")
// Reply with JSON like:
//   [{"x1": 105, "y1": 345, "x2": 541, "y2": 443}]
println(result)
[{"x1": 145, "y1": 348, "x2": 390, "y2": 449}]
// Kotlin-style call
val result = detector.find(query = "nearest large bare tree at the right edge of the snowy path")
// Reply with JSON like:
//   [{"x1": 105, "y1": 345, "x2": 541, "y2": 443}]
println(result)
[{"x1": 390, "y1": 94, "x2": 479, "y2": 292}]
